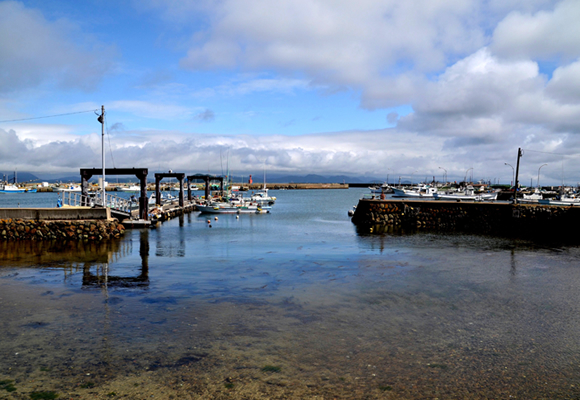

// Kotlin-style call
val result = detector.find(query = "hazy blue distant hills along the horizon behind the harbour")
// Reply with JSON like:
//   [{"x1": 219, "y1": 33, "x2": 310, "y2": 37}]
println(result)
[{"x1": 0, "y1": 171, "x2": 384, "y2": 184}]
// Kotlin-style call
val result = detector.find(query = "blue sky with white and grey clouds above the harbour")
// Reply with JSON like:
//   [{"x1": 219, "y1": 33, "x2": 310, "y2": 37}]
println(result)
[{"x1": 0, "y1": 0, "x2": 580, "y2": 185}]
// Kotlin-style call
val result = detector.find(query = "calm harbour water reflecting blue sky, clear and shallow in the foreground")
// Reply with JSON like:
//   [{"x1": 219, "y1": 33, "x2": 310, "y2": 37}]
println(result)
[{"x1": 0, "y1": 189, "x2": 580, "y2": 399}]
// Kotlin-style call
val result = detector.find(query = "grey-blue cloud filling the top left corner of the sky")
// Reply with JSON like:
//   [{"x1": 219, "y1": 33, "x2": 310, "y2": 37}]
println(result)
[{"x1": 0, "y1": 1, "x2": 114, "y2": 92}]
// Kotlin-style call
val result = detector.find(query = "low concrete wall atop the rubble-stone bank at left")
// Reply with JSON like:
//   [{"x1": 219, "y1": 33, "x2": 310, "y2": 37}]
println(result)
[{"x1": 0, "y1": 207, "x2": 111, "y2": 221}]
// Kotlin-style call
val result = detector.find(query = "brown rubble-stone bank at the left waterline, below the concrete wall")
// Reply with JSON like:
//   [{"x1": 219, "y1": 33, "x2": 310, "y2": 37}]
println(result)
[{"x1": 0, "y1": 219, "x2": 125, "y2": 241}]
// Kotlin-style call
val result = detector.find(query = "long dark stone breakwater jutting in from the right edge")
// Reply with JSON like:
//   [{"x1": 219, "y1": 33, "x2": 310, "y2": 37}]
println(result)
[{"x1": 352, "y1": 199, "x2": 580, "y2": 240}]
